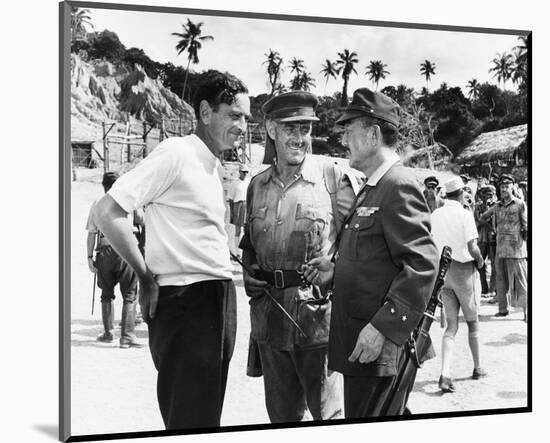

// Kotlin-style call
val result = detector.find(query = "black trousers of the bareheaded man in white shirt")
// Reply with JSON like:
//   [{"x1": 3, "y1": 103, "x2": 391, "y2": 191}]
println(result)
[{"x1": 149, "y1": 280, "x2": 237, "y2": 430}]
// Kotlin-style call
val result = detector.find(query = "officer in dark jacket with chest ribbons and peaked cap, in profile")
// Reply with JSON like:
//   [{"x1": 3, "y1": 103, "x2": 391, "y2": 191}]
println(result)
[{"x1": 305, "y1": 88, "x2": 438, "y2": 418}]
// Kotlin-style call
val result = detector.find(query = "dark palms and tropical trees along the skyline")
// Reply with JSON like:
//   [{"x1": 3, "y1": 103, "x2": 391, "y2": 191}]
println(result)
[{"x1": 71, "y1": 8, "x2": 530, "y2": 161}]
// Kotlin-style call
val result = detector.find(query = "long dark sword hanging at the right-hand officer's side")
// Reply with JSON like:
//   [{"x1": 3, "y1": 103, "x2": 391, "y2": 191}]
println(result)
[{"x1": 380, "y1": 246, "x2": 452, "y2": 416}]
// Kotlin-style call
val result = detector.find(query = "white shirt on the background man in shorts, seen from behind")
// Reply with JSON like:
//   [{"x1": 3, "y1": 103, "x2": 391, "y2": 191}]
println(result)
[{"x1": 432, "y1": 200, "x2": 478, "y2": 263}]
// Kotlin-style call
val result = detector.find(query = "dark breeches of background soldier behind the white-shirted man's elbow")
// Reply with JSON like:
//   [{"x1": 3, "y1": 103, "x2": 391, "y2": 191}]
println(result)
[{"x1": 96, "y1": 246, "x2": 137, "y2": 303}]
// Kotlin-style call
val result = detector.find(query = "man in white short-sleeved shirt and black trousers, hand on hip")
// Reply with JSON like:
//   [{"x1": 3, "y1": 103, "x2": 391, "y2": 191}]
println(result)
[{"x1": 96, "y1": 71, "x2": 250, "y2": 429}]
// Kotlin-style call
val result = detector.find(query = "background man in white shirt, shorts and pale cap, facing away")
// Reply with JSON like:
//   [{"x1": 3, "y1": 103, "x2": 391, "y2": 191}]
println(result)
[{"x1": 432, "y1": 177, "x2": 487, "y2": 392}]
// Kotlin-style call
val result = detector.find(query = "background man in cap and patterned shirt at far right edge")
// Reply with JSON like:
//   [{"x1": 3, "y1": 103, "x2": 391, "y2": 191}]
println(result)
[{"x1": 481, "y1": 174, "x2": 528, "y2": 320}]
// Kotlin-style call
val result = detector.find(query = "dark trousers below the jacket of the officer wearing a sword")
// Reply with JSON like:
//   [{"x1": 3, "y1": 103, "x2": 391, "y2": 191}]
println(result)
[{"x1": 344, "y1": 375, "x2": 412, "y2": 418}]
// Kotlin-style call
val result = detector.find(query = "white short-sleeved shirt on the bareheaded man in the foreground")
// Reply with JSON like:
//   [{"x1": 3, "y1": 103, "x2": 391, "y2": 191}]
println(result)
[{"x1": 109, "y1": 135, "x2": 233, "y2": 286}]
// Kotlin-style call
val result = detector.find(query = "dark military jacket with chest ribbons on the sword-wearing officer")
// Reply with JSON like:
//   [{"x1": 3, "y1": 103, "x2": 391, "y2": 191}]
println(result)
[{"x1": 329, "y1": 162, "x2": 438, "y2": 376}]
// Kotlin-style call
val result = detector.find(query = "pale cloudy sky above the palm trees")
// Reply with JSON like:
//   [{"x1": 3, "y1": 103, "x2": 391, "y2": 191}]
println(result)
[{"x1": 83, "y1": 9, "x2": 519, "y2": 95}]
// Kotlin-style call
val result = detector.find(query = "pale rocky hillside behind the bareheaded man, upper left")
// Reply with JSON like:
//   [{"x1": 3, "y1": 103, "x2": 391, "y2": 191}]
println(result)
[{"x1": 71, "y1": 54, "x2": 194, "y2": 141}]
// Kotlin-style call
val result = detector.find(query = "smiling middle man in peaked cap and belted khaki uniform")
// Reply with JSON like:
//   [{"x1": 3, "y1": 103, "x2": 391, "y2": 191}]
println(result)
[{"x1": 241, "y1": 91, "x2": 360, "y2": 423}]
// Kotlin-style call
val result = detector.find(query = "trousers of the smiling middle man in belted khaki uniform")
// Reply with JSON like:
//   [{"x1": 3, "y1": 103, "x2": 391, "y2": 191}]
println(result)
[{"x1": 258, "y1": 343, "x2": 342, "y2": 423}]
